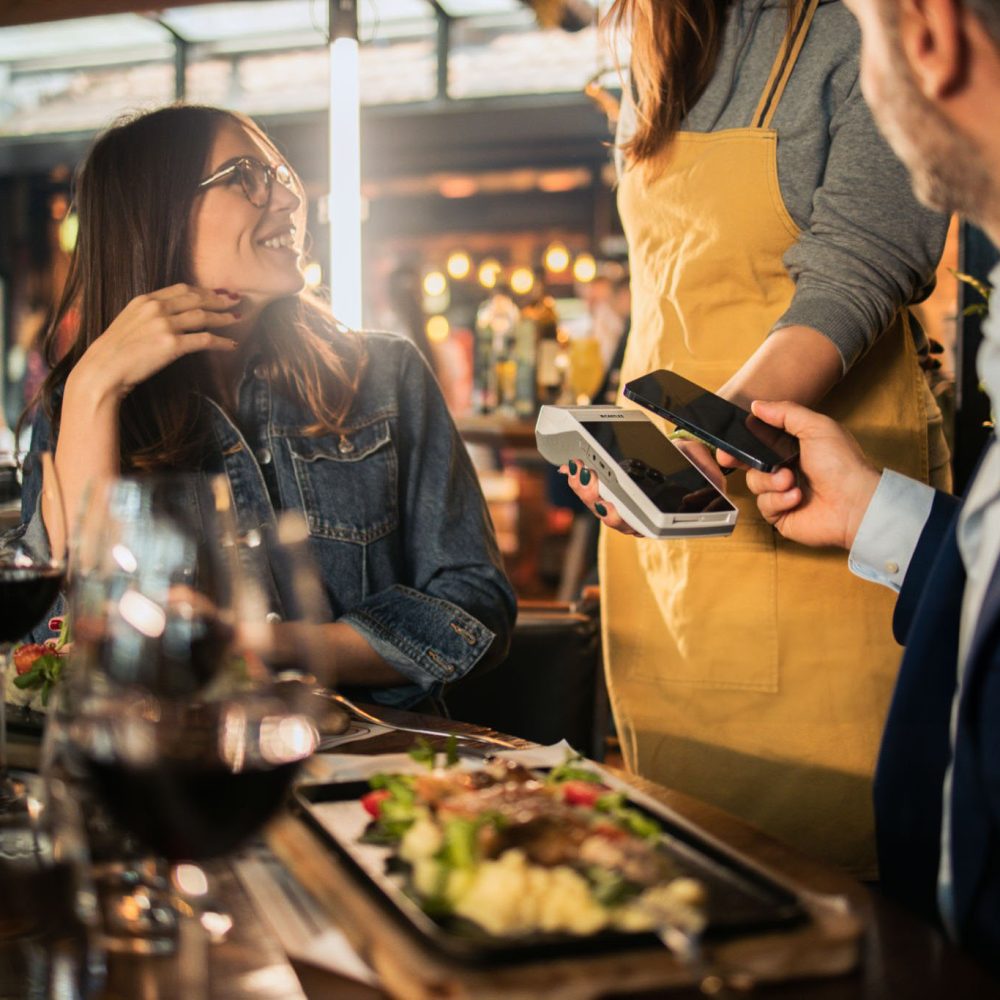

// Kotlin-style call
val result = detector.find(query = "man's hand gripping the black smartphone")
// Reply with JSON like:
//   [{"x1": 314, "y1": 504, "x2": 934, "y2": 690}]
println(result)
[{"x1": 747, "y1": 401, "x2": 880, "y2": 549}]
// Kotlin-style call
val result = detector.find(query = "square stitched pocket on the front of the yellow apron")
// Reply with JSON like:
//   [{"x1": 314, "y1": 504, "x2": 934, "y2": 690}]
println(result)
[{"x1": 629, "y1": 519, "x2": 778, "y2": 693}]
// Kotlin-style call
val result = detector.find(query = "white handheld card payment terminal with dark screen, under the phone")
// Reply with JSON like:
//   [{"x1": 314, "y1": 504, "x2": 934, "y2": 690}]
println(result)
[{"x1": 535, "y1": 406, "x2": 737, "y2": 538}]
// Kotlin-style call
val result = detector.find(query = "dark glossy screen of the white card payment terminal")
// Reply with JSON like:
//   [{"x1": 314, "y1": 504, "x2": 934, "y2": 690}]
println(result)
[{"x1": 580, "y1": 420, "x2": 734, "y2": 514}]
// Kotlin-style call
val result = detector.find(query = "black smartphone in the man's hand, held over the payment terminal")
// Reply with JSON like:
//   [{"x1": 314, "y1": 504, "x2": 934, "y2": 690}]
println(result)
[{"x1": 624, "y1": 368, "x2": 799, "y2": 472}]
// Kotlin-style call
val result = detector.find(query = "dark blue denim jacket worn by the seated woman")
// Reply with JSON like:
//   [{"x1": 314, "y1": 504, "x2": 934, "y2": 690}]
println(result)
[{"x1": 22, "y1": 332, "x2": 516, "y2": 707}]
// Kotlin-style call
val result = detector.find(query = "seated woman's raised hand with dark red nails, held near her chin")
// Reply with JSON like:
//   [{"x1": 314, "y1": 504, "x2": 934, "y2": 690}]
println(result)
[{"x1": 67, "y1": 284, "x2": 240, "y2": 400}]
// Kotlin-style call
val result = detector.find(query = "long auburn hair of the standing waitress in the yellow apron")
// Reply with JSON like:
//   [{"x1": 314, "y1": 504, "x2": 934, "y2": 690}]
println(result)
[{"x1": 605, "y1": 0, "x2": 805, "y2": 163}]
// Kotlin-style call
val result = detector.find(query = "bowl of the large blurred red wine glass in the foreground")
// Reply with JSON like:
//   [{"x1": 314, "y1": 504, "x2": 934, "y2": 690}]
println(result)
[{"x1": 58, "y1": 474, "x2": 318, "y2": 976}]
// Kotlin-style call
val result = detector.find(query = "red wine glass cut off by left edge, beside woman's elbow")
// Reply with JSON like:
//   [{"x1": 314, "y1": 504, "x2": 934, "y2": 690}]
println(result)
[{"x1": 0, "y1": 451, "x2": 66, "y2": 813}]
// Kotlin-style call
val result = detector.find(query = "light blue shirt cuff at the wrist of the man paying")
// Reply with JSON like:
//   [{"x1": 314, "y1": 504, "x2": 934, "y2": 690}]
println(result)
[{"x1": 847, "y1": 469, "x2": 934, "y2": 591}]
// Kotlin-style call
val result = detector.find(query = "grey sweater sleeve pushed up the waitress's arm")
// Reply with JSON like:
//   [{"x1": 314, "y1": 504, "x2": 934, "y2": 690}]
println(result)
[{"x1": 772, "y1": 73, "x2": 948, "y2": 372}]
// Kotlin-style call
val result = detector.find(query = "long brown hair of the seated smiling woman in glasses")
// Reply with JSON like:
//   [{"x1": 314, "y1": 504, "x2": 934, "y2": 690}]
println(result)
[{"x1": 29, "y1": 104, "x2": 366, "y2": 469}]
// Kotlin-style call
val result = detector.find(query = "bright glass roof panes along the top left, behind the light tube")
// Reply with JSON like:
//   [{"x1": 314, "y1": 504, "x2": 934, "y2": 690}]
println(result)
[{"x1": 0, "y1": 0, "x2": 613, "y2": 141}]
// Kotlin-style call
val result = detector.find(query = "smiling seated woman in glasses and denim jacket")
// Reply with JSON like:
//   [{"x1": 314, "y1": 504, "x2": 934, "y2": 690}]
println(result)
[{"x1": 17, "y1": 105, "x2": 515, "y2": 705}]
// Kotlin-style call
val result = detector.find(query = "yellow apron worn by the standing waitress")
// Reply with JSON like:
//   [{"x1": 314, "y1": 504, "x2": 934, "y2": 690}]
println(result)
[{"x1": 599, "y1": 0, "x2": 928, "y2": 877}]
